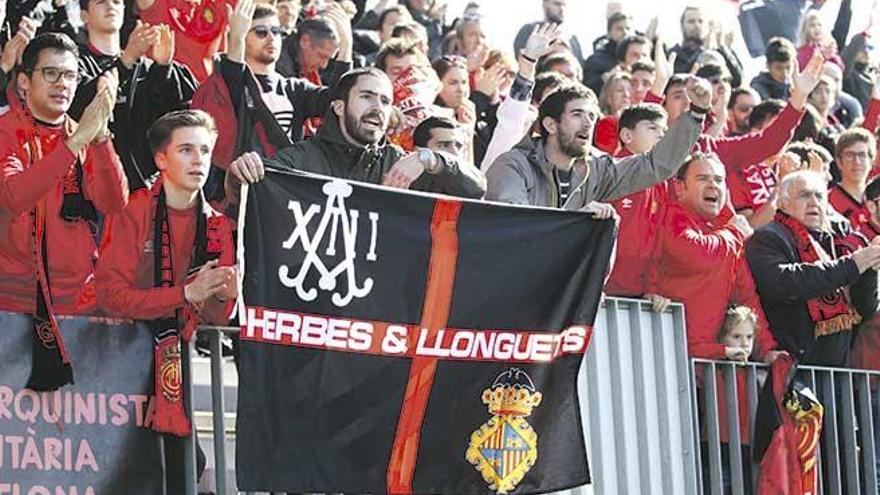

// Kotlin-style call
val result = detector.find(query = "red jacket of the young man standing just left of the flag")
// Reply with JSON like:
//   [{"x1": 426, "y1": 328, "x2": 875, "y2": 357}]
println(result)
[{"x1": 95, "y1": 189, "x2": 235, "y2": 324}]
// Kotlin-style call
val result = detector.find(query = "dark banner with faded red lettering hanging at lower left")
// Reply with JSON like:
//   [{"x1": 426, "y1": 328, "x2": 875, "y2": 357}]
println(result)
[{"x1": 0, "y1": 312, "x2": 165, "y2": 495}]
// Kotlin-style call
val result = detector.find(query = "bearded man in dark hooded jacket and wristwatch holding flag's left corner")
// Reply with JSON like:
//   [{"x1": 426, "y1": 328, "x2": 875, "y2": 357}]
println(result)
[{"x1": 226, "y1": 68, "x2": 486, "y2": 203}]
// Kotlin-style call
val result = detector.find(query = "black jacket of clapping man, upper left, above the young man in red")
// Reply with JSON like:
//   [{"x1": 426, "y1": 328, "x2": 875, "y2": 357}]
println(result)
[{"x1": 68, "y1": 45, "x2": 198, "y2": 191}]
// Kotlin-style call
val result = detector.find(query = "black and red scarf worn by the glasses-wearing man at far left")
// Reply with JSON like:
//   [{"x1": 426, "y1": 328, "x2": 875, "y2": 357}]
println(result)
[{"x1": 15, "y1": 92, "x2": 98, "y2": 391}]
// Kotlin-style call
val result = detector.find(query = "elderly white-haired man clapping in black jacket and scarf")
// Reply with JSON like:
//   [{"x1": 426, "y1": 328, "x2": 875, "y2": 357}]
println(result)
[{"x1": 746, "y1": 171, "x2": 880, "y2": 366}]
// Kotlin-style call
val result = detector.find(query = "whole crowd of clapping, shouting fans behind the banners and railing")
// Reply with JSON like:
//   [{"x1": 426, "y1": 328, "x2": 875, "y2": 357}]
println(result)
[{"x1": 0, "y1": 0, "x2": 880, "y2": 490}]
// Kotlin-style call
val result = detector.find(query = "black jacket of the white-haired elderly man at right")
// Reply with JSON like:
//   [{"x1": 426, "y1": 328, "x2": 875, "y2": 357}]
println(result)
[{"x1": 746, "y1": 221, "x2": 877, "y2": 366}]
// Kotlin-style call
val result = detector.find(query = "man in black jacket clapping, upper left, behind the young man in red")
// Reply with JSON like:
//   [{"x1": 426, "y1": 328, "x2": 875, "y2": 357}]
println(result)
[{"x1": 70, "y1": 0, "x2": 196, "y2": 191}]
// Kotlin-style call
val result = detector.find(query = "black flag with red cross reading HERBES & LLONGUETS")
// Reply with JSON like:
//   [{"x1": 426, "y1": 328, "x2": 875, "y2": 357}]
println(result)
[{"x1": 236, "y1": 173, "x2": 615, "y2": 494}]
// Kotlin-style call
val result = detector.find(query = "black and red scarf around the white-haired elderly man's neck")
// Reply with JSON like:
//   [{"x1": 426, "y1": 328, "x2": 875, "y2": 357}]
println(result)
[{"x1": 775, "y1": 211, "x2": 862, "y2": 337}]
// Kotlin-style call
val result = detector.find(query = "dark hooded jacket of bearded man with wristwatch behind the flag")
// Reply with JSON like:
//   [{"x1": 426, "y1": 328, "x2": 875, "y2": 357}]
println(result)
[{"x1": 226, "y1": 110, "x2": 486, "y2": 199}]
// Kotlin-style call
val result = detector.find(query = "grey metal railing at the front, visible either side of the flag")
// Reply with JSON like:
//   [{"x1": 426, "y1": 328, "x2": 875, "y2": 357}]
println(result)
[{"x1": 187, "y1": 298, "x2": 880, "y2": 495}]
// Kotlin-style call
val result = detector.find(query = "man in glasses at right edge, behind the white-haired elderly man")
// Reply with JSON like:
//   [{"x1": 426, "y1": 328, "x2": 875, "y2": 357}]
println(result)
[{"x1": 828, "y1": 128, "x2": 880, "y2": 239}]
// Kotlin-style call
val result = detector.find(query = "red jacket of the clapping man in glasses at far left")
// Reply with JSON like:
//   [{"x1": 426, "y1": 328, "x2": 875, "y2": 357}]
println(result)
[{"x1": 0, "y1": 104, "x2": 128, "y2": 314}]
